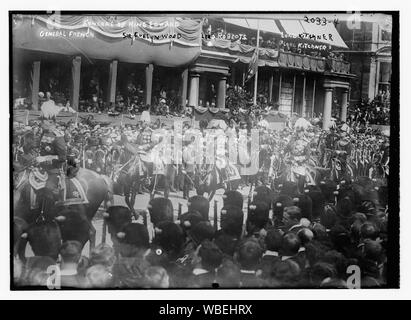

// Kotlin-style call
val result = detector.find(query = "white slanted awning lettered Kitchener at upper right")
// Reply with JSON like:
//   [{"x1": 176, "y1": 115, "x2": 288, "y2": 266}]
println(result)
[{"x1": 279, "y1": 19, "x2": 348, "y2": 48}]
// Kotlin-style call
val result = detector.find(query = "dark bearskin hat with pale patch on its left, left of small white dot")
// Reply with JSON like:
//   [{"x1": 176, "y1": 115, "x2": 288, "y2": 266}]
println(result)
[{"x1": 117, "y1": 223, "x2": 149, "y2": 257}]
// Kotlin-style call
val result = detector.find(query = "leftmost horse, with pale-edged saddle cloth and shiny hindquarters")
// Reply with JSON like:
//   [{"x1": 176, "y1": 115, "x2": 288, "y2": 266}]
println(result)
[{"x1": 14, "y1": 168, "x2": 113, "y2": 259}]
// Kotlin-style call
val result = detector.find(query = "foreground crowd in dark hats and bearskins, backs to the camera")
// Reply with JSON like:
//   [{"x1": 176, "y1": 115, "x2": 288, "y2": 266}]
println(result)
[{"x1": 14, "y1": 178, "x2": 387, "y2": 288}]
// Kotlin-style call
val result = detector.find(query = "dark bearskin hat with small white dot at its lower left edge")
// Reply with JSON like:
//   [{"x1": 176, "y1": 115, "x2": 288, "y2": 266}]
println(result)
[{"x1": 154, "y1": 221, "x2": 184, "y2": 256}]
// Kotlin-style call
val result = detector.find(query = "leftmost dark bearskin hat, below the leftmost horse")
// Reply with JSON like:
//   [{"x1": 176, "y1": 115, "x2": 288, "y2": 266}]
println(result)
[{"x1": 22, "y1": 221, "x2": 62, "y2": 260}]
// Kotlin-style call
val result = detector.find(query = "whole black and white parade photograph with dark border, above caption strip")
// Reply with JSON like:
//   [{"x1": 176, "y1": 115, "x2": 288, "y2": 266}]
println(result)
[{"x1": 10, "y1": 10, "x2": 400, "y2": 291}]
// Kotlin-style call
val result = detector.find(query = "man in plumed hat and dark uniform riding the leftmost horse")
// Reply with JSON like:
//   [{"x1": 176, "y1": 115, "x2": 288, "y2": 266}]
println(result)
[{"x1": 36, "y1": 122, "x2": 67, "y2": 211}]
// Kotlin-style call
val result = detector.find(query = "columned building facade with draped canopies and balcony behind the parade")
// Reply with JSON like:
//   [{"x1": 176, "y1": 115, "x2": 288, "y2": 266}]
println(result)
[{"x1": 13, "y1": 15, "x2": 358, "y2": 127}]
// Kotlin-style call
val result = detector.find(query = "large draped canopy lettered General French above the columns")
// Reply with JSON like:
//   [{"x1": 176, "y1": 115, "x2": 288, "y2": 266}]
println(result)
[{"x1": 13, "y1": 15, "x2": 202, "y2": 67}]
